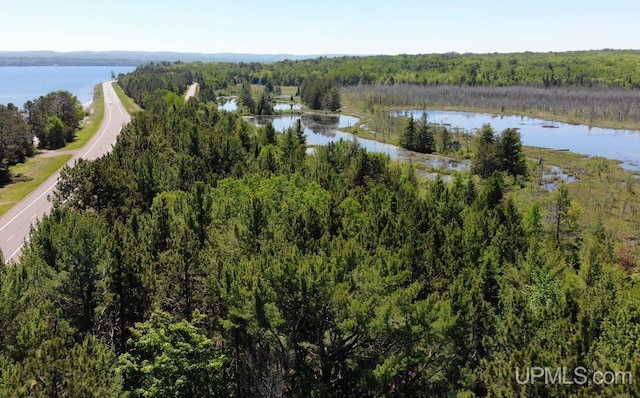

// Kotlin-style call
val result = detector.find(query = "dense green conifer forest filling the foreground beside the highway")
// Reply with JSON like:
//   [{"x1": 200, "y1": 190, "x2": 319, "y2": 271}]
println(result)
[{"x1": 0, "y1": 88, "x2": 640, "y2": 397}]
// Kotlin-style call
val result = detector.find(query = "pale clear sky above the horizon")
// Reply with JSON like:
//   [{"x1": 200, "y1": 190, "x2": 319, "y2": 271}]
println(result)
[{"x1": 0, "y1": 0, "x2": 640, "y2": 55}]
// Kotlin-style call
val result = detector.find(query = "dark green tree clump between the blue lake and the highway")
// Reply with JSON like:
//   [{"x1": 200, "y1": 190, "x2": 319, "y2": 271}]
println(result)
[{"x1": 0, "y1": 91, "x2": 85, "y2": 185}]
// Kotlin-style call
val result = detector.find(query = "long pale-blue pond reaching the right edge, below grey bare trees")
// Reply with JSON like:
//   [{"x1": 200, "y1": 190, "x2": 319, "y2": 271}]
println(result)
[{"x1": 392, "y1": 109, "x2": 640, "y2": 170}]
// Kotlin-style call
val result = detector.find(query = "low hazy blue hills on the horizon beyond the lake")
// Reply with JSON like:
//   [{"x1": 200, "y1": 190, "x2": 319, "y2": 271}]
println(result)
[{"x1": 0, "y1": 51, "x2": 342, "y2": 66}]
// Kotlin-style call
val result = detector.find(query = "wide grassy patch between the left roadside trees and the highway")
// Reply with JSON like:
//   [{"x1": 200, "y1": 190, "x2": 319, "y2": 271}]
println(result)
[{"x1": 0, "y1": 154, "x2": 72, "y2": 216}]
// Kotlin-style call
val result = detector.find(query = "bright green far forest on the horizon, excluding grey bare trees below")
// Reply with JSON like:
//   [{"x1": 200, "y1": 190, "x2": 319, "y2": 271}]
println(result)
[{"x1": 169, "y1": 50, "x2": 640, "y2": 88}]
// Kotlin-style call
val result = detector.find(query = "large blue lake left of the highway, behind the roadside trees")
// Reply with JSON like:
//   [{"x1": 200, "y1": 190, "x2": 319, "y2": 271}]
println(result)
[{"x1": 0, "y1": 66, "x2": 135, "y2": 108}]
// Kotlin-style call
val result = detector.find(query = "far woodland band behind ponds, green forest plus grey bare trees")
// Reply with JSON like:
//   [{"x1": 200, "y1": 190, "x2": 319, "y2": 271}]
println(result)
[{"x1": 117, "y1": 50, "x2": 640, "y2": 123}]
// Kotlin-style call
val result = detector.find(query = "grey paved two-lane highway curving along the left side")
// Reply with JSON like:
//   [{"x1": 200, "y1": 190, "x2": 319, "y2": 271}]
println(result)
[{"x1": 0, "y1": 82, "x2": 131, "y2": 263}]
